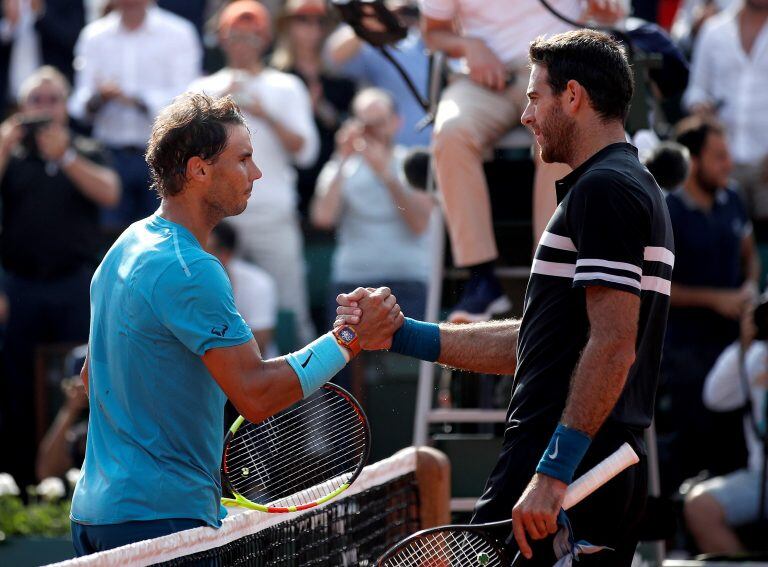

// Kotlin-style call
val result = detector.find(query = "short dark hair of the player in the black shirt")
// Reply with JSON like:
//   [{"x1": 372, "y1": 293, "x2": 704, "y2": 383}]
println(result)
[{"x1": 528, "y1": 29, "x2": 635, "y2": 122}]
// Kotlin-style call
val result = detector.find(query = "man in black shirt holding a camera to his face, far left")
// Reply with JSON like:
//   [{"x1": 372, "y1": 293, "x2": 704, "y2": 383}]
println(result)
[{"x1": 0, "y1": 67, "x2": 120, "y2": 492}]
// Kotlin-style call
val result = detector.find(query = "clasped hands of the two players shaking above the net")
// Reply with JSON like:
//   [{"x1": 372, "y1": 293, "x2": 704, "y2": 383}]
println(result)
[{"x1": 333, "y1": 287, "x2": 404, "y2": 350}]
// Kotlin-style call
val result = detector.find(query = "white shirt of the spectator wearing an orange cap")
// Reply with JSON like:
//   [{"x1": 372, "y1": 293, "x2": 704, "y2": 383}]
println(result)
[{"x1": 189, "y1": 67, "x2": 320, "y2": 223}]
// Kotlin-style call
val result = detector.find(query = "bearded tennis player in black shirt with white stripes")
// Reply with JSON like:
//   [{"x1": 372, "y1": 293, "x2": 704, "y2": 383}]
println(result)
[{"x1": 339, "y1": 30, "x2": 674, "y2": 566}]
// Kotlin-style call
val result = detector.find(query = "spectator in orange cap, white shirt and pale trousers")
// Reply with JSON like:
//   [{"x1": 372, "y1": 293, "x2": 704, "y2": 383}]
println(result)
[{"x1": 190, "y1": 0, "x2": 319, "y2": 341}]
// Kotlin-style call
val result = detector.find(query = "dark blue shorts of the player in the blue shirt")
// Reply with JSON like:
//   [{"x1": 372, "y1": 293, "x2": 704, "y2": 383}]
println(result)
[{"x1": 72, "y1": 518, "x2": 207, "y2": 557}]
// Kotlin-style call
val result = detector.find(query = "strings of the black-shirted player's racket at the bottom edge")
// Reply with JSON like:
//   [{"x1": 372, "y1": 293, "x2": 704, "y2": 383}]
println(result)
[{"x1": 381, "y1": 530, "x2": 502, "y2": 567}]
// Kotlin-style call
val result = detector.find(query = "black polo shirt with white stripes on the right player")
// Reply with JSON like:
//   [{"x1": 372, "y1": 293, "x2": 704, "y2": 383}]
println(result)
[{"x1": 508, "y1": 143, "x2": 674, "y2": 448}]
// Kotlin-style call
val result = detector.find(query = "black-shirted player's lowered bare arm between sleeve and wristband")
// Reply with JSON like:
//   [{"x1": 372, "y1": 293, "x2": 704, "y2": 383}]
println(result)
[{"x1": 561, "y1": 287, "x2": 640, "y2": 437}]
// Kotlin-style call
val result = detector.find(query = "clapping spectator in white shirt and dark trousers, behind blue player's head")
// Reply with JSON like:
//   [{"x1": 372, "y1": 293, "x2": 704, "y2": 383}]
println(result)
[{"x1": 70, "y1": 0, "x2": 202, "y2": 230}]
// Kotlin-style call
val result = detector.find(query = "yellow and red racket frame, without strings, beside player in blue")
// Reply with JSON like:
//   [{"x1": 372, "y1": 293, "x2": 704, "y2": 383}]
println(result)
[{"x1": 221, "y1": 382, "x2": 371, "y2": 514}]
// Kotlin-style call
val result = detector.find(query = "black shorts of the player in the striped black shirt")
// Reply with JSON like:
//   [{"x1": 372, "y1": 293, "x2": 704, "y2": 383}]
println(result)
[{"x1": 472, "y1": 430, "x2": 648, "y2": 567}]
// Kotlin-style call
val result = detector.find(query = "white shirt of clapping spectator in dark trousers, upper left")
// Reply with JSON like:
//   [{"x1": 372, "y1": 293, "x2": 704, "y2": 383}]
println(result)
[{"x1": 69, "y1": 7, "x2": 202, "y2": 147}]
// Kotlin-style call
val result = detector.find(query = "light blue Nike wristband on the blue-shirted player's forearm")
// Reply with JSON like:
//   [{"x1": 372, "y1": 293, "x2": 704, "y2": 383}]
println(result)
[{"x1": 285, "y1": 333, "x2": 349, "y2": 398}]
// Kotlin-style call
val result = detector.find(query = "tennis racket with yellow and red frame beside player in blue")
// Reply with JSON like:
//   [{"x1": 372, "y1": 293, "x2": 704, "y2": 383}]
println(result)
[{"x1": 221, "y1": 384, "x2": 371, "y2": 513}]
